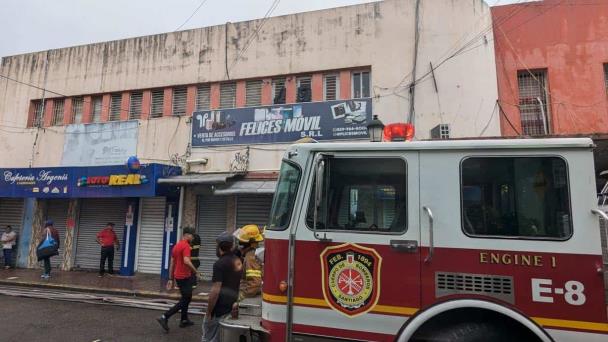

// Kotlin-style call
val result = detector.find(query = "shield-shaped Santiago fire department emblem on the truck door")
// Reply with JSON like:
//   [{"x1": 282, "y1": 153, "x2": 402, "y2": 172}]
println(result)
[{"x1": 321, "y1": 243, "x2": 382, "y2": 317}]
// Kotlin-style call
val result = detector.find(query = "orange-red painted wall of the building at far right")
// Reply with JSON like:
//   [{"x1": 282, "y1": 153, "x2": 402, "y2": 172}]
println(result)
[{"x1": 492, "y1": 0, "x2": 608, "y2": 135}]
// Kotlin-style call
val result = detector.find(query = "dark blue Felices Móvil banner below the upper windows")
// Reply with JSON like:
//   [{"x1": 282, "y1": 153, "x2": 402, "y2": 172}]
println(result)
[{"x1": 192, "y1": 99, "x2": 372, "y2": 147}]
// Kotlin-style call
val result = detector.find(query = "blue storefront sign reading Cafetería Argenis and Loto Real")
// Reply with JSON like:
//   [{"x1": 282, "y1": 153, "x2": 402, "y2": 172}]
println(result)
[{"x1": 0, "y1": 164, "x2": 181, "y2": 198}]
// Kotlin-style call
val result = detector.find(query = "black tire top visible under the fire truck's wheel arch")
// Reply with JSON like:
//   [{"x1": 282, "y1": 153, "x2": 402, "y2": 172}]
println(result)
[{"x1": 427, "y1": 322, "x2": 523, "y2": 342}]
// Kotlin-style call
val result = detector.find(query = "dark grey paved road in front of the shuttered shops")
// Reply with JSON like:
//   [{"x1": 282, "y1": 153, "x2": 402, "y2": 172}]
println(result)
[{"x1": 0, "y1": 295, "x2": 203, "y2": 342}]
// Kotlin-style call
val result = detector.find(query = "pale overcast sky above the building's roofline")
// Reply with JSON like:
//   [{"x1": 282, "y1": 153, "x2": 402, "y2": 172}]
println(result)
[{"x1": 0, "y1": 0, "x2": 523, "y2": 56}]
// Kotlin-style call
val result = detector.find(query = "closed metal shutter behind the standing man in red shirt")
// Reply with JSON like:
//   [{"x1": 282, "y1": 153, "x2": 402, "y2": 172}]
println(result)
[{"x1": 74, "y1": 198, "x2": 127, "y2": 270}]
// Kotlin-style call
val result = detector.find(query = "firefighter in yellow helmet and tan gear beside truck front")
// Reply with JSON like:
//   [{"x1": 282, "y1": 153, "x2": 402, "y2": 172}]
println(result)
[{"x1": 234, "y1": 224, "x2": 264, "y2": 299}]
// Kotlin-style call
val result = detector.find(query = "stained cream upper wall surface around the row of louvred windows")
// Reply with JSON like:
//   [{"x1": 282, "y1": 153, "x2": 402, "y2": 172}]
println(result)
[{"x1": 0, "y1": 0, "x2": 499, "y2": 171}]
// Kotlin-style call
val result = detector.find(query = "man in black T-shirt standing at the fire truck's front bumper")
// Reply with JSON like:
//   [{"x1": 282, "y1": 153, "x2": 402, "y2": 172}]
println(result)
[{"x1": 203, "y1": 232, "x2": 243, "y2": 342}]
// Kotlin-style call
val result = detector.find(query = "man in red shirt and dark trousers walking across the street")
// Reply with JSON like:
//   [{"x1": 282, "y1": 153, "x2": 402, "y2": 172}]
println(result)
[{"x1": 156, "y1": 228, "x2": 196, "y2": 332}]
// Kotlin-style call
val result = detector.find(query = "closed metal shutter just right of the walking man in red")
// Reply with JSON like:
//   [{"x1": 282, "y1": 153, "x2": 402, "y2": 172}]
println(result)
[{"x1": 197, "y1": 196, "x2": 226, "y2": 279}]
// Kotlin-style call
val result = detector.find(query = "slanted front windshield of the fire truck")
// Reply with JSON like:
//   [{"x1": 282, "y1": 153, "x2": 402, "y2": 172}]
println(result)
[{"x1": 268, "y1": 161, "x2": 301, "y2": 230}]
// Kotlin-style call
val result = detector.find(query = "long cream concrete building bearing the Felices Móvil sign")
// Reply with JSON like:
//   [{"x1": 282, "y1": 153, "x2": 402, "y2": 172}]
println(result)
[{"x1": 0, "y1": 0, "x2": 500, "y2": 272}]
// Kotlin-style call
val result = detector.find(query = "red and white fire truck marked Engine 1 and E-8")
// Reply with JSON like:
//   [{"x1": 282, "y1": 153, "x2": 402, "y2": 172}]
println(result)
[{"x1": 222, "y1": 132, "x2": 608, "y2": 342}]
